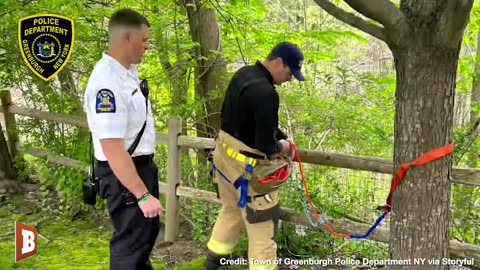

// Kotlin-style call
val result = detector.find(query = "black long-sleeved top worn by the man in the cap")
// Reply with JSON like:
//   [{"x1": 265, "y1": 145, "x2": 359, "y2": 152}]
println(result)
[{"x1": 221, "y1": 61, "x2": 287, "y2": 155}]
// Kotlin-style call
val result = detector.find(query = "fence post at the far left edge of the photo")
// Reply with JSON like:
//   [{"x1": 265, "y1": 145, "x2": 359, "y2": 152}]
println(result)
[{"x1": 0, "y1": 90, "x2": 19, "y2": 160}]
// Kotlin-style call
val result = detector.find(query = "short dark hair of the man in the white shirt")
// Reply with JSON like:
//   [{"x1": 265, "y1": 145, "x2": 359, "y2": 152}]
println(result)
[{"x1": 108, "y1": 8, "x2": 150, "y2": 39}]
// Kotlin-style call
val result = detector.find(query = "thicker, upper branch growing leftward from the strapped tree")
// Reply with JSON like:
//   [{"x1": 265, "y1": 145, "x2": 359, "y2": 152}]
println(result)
[{"x1": 345, "y1": 0, "x2": 403, "y2": 28}]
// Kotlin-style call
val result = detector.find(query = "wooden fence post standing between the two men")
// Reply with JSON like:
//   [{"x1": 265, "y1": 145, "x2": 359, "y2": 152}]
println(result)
[{"x1": 165, "y1": 117, "x2": 182, "y2": 241}]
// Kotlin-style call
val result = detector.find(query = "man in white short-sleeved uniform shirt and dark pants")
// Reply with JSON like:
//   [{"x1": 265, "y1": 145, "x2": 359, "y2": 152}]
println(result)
[{"x1": 84, "y1": 9, "x2": 163, "y2": 270}]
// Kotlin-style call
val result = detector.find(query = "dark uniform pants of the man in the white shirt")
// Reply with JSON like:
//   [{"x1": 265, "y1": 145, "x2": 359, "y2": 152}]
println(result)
[{"x1": 95, "y1": 158, "x2": 160, "y2": 270}]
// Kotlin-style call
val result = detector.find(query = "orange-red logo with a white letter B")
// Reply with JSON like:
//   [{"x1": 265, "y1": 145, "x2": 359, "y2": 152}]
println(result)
[{"x1": 15, "y1": 221, "x2": 37, "y2": 262}]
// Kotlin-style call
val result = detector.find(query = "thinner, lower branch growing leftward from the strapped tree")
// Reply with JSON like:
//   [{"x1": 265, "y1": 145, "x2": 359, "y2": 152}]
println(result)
[{"x1": 314, "y1": 0, "x2": 386, "y2": 41}]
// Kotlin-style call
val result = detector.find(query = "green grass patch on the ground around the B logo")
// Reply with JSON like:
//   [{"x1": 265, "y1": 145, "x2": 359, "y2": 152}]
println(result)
[{"x1": 0, "y1": 196, "x2": 167, "y2": 270}]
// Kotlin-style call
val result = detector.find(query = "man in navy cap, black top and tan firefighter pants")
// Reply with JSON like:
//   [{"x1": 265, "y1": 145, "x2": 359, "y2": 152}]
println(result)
[{"x1": 204, "y1": 42, "x2": 305, "y2": 270}]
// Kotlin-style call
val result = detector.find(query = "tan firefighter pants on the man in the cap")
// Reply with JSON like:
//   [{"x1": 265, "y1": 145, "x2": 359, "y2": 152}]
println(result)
[{"x1": 208, "y1": 130, "x2": 280, "y2": 269}]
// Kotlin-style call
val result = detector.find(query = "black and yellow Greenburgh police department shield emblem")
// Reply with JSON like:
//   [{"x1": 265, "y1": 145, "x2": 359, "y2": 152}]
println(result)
[{"x1": 18, "y1": 14, "x2": 75, "y2": 81}]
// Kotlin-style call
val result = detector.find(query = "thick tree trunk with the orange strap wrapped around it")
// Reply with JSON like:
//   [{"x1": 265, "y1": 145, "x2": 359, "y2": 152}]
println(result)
[{"x1": 390, "y1": 45, "x2": 460, "y2": 269}]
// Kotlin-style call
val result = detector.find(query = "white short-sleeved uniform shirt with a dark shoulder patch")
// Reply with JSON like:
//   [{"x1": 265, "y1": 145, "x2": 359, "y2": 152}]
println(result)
[{"x1": 84, "y1": 53, "x2": 155, "y2": 161}]
